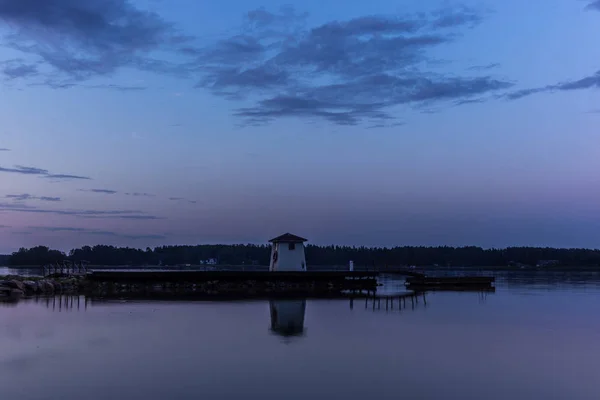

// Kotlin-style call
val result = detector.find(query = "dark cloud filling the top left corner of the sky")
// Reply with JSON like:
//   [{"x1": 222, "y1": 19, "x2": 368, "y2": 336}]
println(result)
[{"x1": 0, "y1": 0, "x2": 189, "y2": 81}]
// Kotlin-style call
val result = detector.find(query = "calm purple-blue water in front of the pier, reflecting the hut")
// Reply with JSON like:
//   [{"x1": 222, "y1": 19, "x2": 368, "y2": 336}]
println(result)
[{"x1": 0, "y1": 274, "x2": 600, "y2": 400}]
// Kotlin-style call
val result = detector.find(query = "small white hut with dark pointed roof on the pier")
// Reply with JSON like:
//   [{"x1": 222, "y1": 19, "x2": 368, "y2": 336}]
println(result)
[{"x1": 269, "y1": 233, "x2": 306, "y2": 271}]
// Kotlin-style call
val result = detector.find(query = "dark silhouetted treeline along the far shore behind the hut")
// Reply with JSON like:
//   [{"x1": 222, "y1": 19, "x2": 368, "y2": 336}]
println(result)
[{"x1": 8, "y1": 245, "x2": 600, "y2": 267}]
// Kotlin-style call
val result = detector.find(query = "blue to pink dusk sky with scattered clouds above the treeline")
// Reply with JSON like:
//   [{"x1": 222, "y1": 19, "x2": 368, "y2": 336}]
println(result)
[{"x1": 0, "y1": 0, "x2": 600, "y2": 253}]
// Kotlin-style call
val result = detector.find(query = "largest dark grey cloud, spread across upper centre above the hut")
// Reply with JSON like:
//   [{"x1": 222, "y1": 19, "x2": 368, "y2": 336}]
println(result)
[{"x1": 195, "y1": 7, "x2": 512, "y2": 125}]
